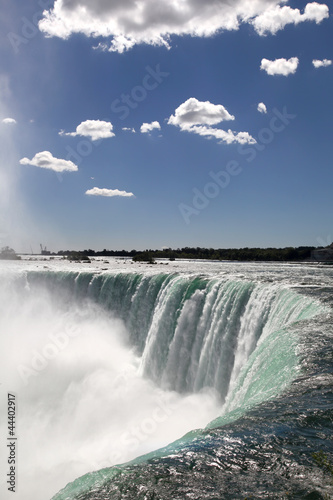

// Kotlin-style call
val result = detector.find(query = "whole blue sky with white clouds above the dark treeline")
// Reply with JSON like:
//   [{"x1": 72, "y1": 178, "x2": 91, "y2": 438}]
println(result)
[{"x1": 0, "y1": 0, "x2": 333, "y2": 252}]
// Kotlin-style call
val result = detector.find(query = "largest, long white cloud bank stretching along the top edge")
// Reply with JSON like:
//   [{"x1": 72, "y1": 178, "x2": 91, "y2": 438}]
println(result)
[{"x1": 39, "y1": 0, "x2": 328, "y2": 52}]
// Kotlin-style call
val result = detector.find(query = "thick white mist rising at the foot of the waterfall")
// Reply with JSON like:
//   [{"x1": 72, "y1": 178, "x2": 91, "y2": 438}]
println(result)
[{"x1": 0, "y1": 274, "x2": 219, "y2": 500}]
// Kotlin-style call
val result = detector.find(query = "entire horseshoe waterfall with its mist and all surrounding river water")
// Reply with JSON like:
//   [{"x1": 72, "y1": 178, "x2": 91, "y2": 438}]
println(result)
[{"x1": 0, "y1": 259, "x2": 333, "y2": 500}]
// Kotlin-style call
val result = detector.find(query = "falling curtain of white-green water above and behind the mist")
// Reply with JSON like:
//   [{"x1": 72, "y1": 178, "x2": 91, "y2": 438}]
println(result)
[{"x1": 22, "y1": 272, "x2": 318, "y2": 409}]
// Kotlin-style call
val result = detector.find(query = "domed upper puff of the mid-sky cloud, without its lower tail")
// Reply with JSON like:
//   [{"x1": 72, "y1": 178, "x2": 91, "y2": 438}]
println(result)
[{"x1": 168, "y1": 97, "x2": 235, "y2": 128}]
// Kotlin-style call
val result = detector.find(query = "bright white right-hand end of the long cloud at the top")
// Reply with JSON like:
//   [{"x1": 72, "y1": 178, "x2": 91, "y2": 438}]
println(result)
[{"x1": 251, "y1": 2, "x2": 329, "y2": 35}]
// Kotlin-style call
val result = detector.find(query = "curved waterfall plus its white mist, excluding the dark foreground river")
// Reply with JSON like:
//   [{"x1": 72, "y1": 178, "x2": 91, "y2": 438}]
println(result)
[{"x1": 0, "y1": 269, "x2": 323, "y2": 500}]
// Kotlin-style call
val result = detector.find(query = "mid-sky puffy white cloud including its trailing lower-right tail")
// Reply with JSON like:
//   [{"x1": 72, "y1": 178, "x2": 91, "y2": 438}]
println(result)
[{"x1": 168, "y1": 97, "x2": 256, "y2": 144}]
